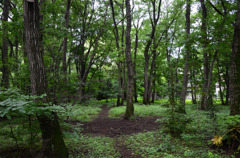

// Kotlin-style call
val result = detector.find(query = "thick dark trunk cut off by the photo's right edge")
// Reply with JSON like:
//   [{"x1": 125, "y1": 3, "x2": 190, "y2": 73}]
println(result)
[{"x1": 229, "y1": 1, "x2": 240, "y2": 115}]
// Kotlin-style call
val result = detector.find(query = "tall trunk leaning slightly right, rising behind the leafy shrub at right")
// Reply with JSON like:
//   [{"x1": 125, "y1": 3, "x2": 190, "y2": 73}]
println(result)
[{"x1": 178, "y1": 0, "x2": 191, "y2": 113}]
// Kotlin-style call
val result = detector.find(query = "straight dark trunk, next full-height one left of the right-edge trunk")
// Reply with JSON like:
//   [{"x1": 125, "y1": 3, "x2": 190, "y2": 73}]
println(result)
[{"x1": 200, "y1": 0, "x2": 209, "y2": 110}]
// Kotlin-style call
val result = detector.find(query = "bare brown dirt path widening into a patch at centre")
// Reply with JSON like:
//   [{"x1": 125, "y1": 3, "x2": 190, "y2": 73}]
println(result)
[{"x1": 83, "y1": 106, "x2": 159, "y2": 158}]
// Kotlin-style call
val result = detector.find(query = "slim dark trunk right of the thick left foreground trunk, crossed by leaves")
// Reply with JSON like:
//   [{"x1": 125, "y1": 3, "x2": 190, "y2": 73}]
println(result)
[{"x1": 62, "y1": 0, "x2": 71, "y2": 80}]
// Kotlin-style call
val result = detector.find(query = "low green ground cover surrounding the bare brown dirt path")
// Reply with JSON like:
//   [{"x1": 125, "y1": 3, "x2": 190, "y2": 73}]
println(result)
[{"x1": 0, "y1": 99, "x2": 234, "y2": 158}]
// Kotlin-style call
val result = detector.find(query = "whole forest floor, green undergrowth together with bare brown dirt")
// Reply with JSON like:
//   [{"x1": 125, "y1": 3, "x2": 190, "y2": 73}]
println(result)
[{"x1": 0, "y1": 100, "x2": 240, "y2": 158}]
